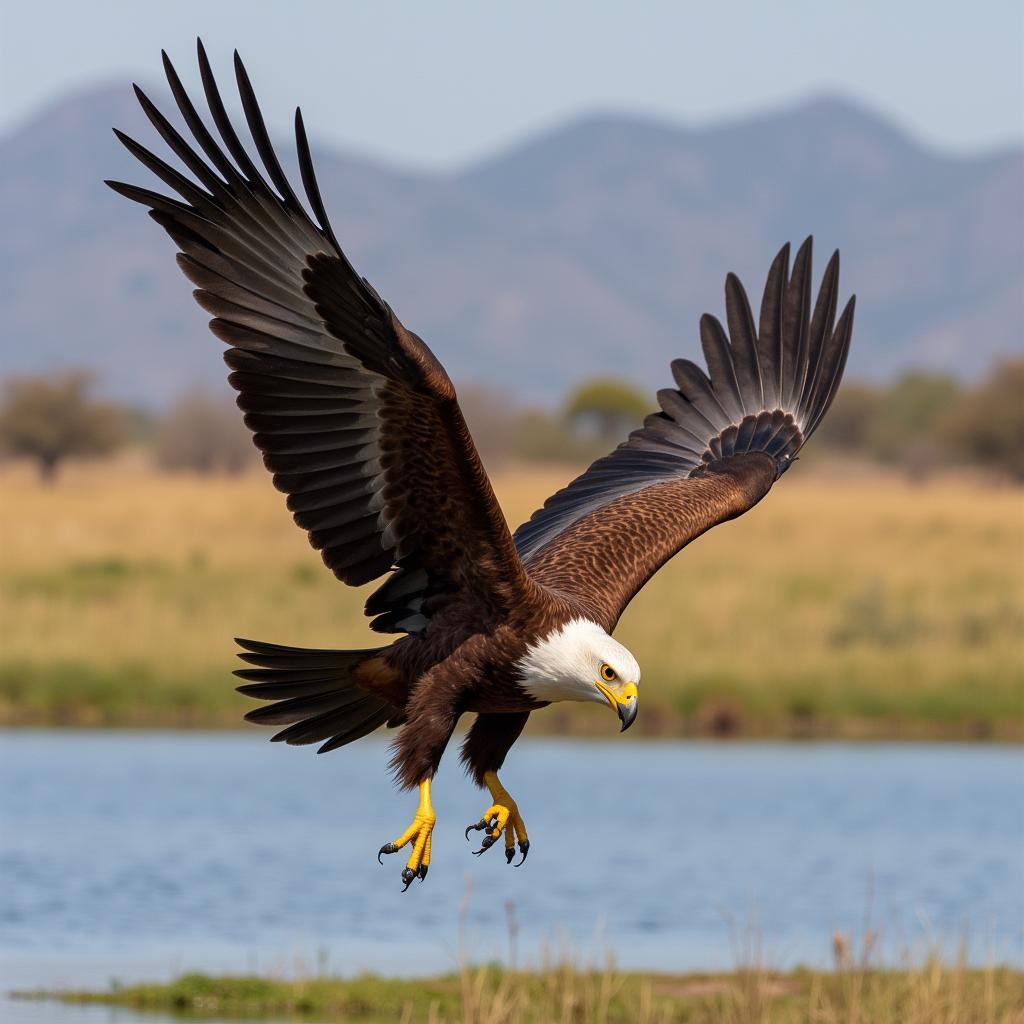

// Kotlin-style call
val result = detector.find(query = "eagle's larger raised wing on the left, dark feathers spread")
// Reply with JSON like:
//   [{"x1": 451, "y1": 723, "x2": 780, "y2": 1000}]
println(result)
[{"x1": 108, "y1": 43, "x2": 530, "y2": 632}]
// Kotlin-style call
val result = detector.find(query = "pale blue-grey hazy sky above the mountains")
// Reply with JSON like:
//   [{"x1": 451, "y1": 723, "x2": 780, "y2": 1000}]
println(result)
[{"x1": 0, "y1": 0, "x2": 1024, "y2": 167}]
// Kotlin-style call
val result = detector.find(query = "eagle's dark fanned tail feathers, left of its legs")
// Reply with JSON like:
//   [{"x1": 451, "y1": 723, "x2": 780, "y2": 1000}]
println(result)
[{"x1": 234, "y1": 638, "x2": 400, "y2": 754}]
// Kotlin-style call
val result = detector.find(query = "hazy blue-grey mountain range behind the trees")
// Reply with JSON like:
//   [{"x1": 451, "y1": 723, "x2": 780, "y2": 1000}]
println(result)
[{"x1": 0, "y1": 83, "x2": 1024, "y2": 403}]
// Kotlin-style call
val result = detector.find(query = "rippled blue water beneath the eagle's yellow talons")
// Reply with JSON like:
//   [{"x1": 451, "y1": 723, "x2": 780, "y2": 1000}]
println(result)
[{"x1": 0, "y1": 731, "x2": 1024, "y2": 1020}]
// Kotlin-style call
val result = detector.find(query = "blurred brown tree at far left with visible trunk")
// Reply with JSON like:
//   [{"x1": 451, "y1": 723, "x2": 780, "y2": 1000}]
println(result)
[{"x1": 0, "y1": 370, "x2": 125, "y2": 483}]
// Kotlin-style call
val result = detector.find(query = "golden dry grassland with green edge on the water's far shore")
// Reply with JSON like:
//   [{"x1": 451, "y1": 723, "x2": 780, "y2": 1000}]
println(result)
[{"x1": 0, "y1": 466, "x2": 1024, "y2": 739}]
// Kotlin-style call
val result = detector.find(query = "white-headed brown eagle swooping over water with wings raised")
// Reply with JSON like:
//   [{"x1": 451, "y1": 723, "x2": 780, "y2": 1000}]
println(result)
[{"x1": 106, "y1": 41, "x2": 855, "y2": 891}]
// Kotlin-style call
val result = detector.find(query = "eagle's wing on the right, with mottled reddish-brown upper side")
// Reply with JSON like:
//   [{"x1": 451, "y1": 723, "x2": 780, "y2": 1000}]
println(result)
[{"x1": 514, "y1": 239, "x2": 854, "y2": 630}]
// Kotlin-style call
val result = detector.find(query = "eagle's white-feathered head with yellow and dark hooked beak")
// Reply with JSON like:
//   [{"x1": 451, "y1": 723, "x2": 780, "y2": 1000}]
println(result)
[{"x1": 516, "y1": 618, "x2": 640, "y2": 729}]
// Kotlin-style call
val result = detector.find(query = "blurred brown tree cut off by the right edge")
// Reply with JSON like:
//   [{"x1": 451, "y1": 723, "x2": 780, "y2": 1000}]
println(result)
[{"x1": 941, "y1": 356, "x2": 1024, "y2": 482}]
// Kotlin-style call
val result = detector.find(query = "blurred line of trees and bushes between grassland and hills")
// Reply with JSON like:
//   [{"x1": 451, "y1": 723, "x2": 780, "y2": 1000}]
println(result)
[{"x1": 8, "y1": 356, "x2": 1024, "y2": 482}]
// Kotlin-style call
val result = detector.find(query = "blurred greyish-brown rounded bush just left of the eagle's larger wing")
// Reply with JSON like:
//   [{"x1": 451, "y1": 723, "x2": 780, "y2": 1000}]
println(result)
[{"x1": 156, "y1": 393, "x2": 256, "y2": 473}]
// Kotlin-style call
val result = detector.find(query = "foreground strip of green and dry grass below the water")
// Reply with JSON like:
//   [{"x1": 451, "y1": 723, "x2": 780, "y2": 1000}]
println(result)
[{"x1": 22, "y1": 959, "x2": 1024, "y2": 1024}]
